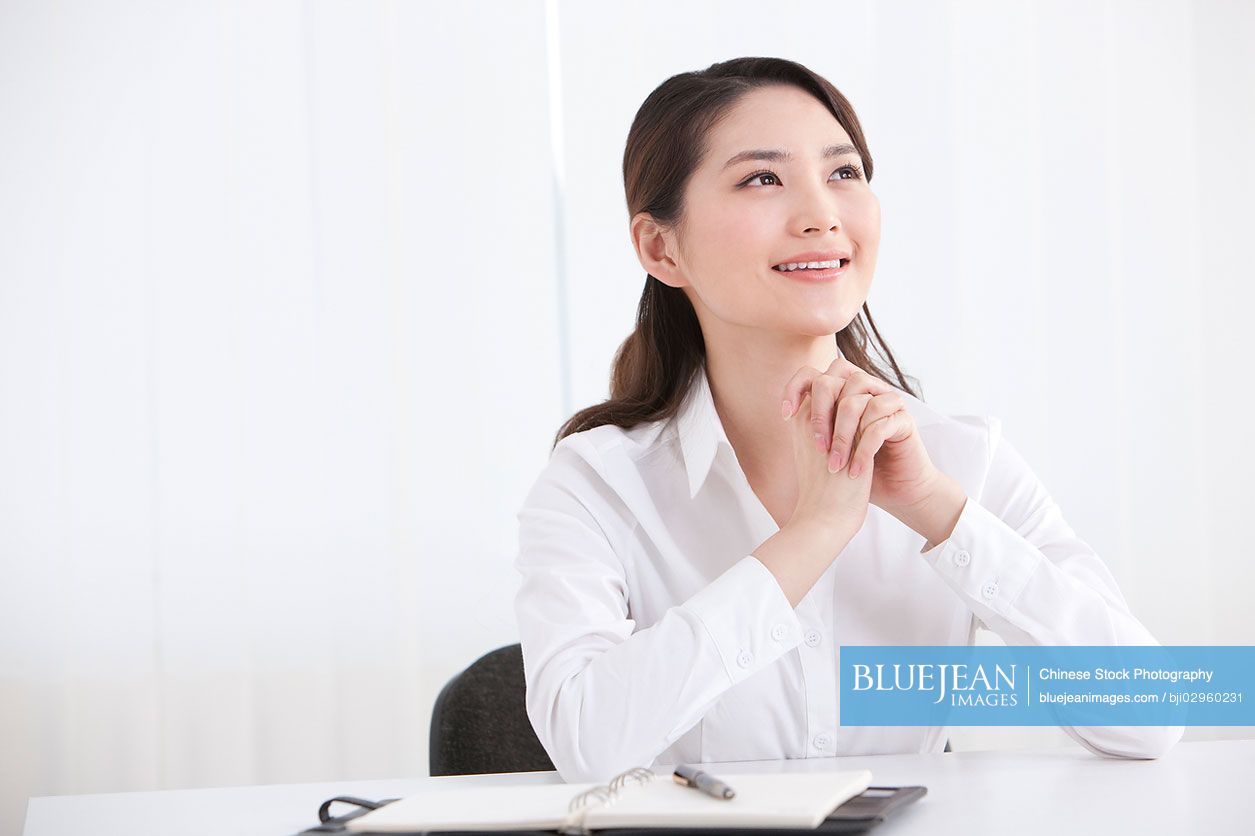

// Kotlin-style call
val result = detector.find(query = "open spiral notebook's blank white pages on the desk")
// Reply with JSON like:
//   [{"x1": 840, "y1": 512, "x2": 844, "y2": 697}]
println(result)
[{"x1": 345, "y1": 768, "x2": 871, "y2": 832}]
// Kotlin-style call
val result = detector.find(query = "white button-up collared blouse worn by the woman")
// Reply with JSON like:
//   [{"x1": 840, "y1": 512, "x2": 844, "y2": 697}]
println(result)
[{"x1": 515, "y1": 372, "x2": 1185, "y2": 782}]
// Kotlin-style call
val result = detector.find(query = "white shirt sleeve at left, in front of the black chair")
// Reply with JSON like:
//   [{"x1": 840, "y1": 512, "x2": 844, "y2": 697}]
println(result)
[{"x1": 515, "y1": 446, "x2": 802, "y2": 782}]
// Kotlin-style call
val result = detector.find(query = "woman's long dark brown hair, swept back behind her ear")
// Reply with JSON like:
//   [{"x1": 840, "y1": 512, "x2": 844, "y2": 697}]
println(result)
[{"x1": 553, "y1": 58, "x2": 920, "y2": 447}]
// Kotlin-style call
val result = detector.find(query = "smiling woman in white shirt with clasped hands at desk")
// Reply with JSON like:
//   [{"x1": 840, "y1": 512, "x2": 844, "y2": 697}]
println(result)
[{"x1": 516, "y1": 58, "x2": 1183, "y2": 781}]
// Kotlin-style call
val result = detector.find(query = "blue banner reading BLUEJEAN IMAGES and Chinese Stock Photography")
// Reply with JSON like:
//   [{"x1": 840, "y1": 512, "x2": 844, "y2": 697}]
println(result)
[{"x1": 838, "y1": 645, "x2": 1255, "y2": 726}]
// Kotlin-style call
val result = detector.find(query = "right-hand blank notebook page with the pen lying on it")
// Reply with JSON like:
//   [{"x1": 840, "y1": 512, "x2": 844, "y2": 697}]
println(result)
[{"x1": 586, "y1": 769, "x2": 871, "y2": 830}]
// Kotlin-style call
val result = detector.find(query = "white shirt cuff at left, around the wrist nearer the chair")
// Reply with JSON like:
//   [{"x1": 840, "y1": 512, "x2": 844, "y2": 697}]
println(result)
[{"x1": 683, "y1": 555, "x2": 802, "y2": 684}]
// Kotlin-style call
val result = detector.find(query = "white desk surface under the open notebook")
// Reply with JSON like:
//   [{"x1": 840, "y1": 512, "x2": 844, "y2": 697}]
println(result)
[{"x1": 24, "y1": 741, "x2": 1255, "y2": 836}]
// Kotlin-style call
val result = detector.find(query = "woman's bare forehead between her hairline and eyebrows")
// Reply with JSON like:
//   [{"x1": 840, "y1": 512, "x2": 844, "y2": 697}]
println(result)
[{"x1": 707, "y1": 85, "x2": 853, "y2": 158}]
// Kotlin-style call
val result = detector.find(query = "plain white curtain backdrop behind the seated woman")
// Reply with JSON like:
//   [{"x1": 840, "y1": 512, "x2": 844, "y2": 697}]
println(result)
[{"x1": 0, "y1": 0, "x2": 1255, "y2": 832}]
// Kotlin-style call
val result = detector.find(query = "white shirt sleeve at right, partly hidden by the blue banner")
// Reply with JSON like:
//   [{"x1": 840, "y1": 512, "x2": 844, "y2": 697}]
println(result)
[{"x1": 921, "y1": 417, "x2": 1185, "y2": 758}]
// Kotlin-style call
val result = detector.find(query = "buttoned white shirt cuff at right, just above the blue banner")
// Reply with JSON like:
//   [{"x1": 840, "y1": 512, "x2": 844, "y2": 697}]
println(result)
[{"x1": 920, "y1": 497, "x2": 1045, "y2": 615}]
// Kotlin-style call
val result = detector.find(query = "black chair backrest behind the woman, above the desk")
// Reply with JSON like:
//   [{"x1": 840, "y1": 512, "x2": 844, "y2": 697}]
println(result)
[{"x1": 429, "y1": 644, "x2": 553, "y2": 776}]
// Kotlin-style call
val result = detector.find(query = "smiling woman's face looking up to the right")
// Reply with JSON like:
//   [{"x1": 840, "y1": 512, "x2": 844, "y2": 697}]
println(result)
[{"x1": 654, "y1": 85, "x2": 880, "y2": 336}]
